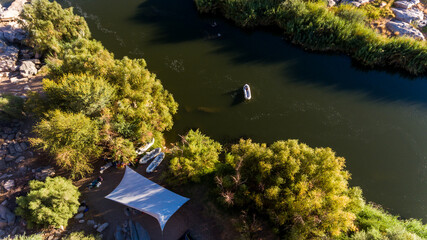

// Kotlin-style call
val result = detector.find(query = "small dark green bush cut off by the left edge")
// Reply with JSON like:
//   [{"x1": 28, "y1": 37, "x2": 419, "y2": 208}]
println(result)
[{"x1": 0, "y1": 94, "x2": 24, "y2": 120}]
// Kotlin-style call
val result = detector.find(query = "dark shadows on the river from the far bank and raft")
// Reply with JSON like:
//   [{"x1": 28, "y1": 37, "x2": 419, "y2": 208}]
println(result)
[{"x1": 132, "y1": 0, "x2": 427, "y2": 107}]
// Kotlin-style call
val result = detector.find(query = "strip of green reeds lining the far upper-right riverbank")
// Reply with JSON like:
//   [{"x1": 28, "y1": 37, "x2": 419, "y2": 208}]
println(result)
[{"x1": 195, "y1": 0, "x2": 427, "y2": 75}]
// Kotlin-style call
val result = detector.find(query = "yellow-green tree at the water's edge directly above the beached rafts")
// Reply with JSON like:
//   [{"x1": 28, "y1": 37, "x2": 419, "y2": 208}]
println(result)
[{"x1": 107, "y1": 57, "x2": 178, "y2": 142}]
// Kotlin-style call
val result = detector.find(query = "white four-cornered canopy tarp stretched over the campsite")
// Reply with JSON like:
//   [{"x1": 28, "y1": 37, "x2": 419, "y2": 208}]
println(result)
[{"x1": 105, "y1": 166, "x2": 189, "y2": 231}]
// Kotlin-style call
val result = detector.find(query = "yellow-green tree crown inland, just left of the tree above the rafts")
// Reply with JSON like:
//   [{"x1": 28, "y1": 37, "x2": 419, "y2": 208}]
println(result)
[{"x1": 43, "y1": 74, "x2": 115, "y2": 116}]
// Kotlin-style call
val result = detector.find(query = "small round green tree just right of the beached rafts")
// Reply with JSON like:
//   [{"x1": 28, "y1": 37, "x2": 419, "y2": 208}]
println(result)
[{"x1": 169, "y1": 129, "x2": 222, "y2": 182}]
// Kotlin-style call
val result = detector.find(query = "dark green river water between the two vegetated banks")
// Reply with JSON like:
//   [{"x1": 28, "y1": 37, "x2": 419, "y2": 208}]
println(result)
[{"x1": 61, "y1": 0, "x2": 427, "y2": 221}]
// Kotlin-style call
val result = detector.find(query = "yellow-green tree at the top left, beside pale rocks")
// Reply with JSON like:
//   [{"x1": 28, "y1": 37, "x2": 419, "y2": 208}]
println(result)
[{"x1": 21, "y1": 0, "x2": 90, "y2": 53}]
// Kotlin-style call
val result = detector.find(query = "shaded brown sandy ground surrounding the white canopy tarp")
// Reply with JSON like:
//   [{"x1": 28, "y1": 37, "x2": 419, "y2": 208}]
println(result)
[{"x1": 73, "y1": 165, "x2": 239, "y2": 240}]
